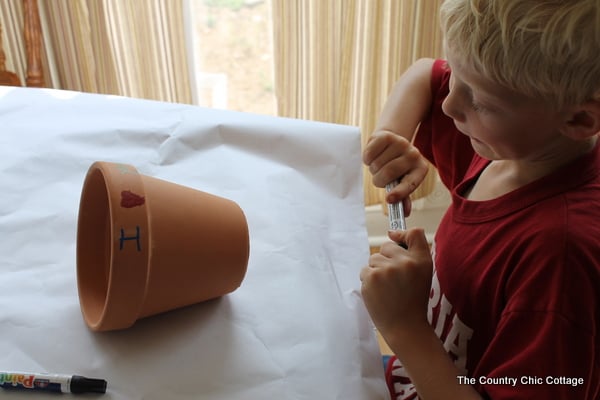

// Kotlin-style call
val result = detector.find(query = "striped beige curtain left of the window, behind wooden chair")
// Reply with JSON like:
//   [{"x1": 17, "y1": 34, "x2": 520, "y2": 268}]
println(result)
[{"x1": 0, "y1": 0, "x2": 192, "y2": 104}]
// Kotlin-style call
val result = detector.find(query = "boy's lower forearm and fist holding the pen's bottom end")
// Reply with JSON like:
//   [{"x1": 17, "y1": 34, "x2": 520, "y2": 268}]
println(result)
[{"x1": 360, "y1": 229, "x2": 481, "y2": 400}]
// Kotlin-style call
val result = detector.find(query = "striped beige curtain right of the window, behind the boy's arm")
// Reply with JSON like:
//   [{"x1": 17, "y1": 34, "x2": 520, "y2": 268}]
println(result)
[{"x1": 272, "y1": 0, "x2": 442, "y2": 205}]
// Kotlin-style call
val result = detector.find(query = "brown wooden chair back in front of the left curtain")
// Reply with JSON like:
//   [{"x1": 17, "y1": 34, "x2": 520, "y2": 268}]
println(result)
[{"x1": 0, "y1": 0, "x2": 44, "y2": 87}]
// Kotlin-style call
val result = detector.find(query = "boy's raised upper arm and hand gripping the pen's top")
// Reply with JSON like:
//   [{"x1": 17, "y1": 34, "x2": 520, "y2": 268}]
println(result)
[{"x1": 363, "y1": 58, "x2": 434, "y2": 203}]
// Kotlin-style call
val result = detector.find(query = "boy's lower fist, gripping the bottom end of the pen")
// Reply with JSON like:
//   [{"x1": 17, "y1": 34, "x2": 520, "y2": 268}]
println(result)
[{"x1": 360, "y1": 229, "x2": 433, "y2": 338}]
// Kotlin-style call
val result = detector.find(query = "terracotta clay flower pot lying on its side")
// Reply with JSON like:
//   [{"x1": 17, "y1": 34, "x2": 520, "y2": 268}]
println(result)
[{"x1": 77, "y1": 162, "x2": 249, "y2": 331}]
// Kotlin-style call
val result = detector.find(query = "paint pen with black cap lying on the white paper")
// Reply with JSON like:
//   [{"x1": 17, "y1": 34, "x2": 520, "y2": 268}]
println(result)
[{"x1": 0, "y1": 371, "x2": 107, "y2": 393}]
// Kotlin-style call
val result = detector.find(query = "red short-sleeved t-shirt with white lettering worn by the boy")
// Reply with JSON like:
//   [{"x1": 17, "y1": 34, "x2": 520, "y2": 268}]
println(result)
[{"x1": 387, "y1": 60, "x2": 600, "y2": 400}]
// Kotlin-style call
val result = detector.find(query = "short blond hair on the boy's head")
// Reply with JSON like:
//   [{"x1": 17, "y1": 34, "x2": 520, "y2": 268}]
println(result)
[{"x1": 440, "y1": 0, "x2": 600, "y2": 108}]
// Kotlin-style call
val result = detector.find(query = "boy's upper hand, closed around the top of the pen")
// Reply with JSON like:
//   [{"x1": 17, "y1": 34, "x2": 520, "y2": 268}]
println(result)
[{"x1": 363, "y1": 130, "x2": 428, "y2": 206}]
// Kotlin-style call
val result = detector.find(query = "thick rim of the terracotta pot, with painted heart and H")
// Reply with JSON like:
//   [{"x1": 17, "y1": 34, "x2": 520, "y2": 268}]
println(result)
[{"x1": 77, "y1": 161, "x2": 150, "y2": 331}]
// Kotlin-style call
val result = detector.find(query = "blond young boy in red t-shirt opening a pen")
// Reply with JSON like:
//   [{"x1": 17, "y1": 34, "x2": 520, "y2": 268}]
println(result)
[{"x1": 360, "y1": 0, "x2": 600, "y2": 400}]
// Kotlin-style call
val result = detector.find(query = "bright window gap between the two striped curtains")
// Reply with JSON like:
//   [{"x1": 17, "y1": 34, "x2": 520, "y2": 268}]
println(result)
[{"x1": 188, "y1": 0, "x2": 276, "y2": 115}]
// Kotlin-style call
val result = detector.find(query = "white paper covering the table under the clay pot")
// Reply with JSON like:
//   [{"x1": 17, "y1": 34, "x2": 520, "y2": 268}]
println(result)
[{"x1": 0, "y1": 87, "x2": 387, "y2": 400}]
